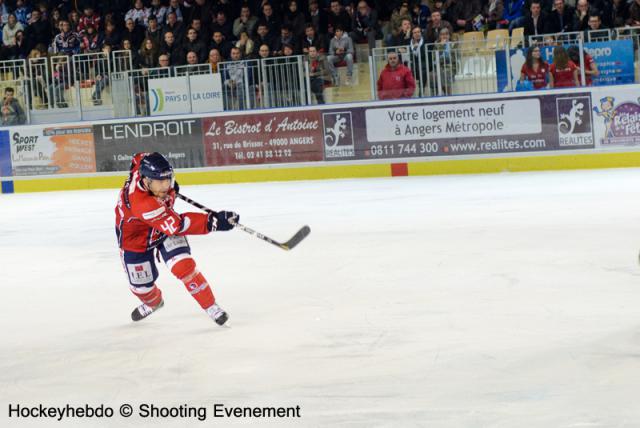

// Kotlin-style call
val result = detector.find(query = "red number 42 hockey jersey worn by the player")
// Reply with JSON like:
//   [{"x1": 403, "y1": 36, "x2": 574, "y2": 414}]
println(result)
[{"x1": 115, "y1": 153, "x2": 209, "y2": 252}]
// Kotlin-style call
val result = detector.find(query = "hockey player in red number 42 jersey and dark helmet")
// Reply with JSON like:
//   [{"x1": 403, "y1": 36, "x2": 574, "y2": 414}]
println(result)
[{"x1": 116, "y1": 153, "x2": 240, "y2": 325}]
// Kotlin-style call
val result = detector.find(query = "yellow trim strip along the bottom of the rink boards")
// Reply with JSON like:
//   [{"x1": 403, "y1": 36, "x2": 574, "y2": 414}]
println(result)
[{"x1": 14, "y1": 152, "x2": 640, "y2": 193}]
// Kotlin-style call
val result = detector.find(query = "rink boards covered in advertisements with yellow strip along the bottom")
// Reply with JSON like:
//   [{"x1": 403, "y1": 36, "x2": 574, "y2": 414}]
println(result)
[{"x1": 0, "y1": 85, "x2": 640, "y2": 193}]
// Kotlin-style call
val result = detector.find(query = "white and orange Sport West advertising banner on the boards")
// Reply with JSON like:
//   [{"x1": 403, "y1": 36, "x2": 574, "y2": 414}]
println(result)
[{"x1": 9, "y1": 126, "x2": 96, "y2": 176}]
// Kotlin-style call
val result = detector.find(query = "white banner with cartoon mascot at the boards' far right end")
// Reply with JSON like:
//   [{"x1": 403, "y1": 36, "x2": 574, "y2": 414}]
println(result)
[{"x1": 592, "y1": 86, "x2": 640, "y2": 148}]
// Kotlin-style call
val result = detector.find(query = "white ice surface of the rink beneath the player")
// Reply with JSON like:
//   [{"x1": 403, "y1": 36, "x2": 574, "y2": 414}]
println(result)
[{"x1": 0, "y1": 169, "x2": 640, "y2": 428}]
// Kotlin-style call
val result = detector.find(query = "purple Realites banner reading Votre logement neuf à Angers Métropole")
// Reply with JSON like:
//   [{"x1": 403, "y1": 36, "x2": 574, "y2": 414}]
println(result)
[{"x1": 322, "y1": 92, "x2": 594, "y2": 160}]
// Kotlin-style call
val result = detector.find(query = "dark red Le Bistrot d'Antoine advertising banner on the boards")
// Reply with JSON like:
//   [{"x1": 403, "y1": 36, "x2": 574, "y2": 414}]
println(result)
[{"x1": 202, "y1": 110, "x2": 323, "y2": 166}]
